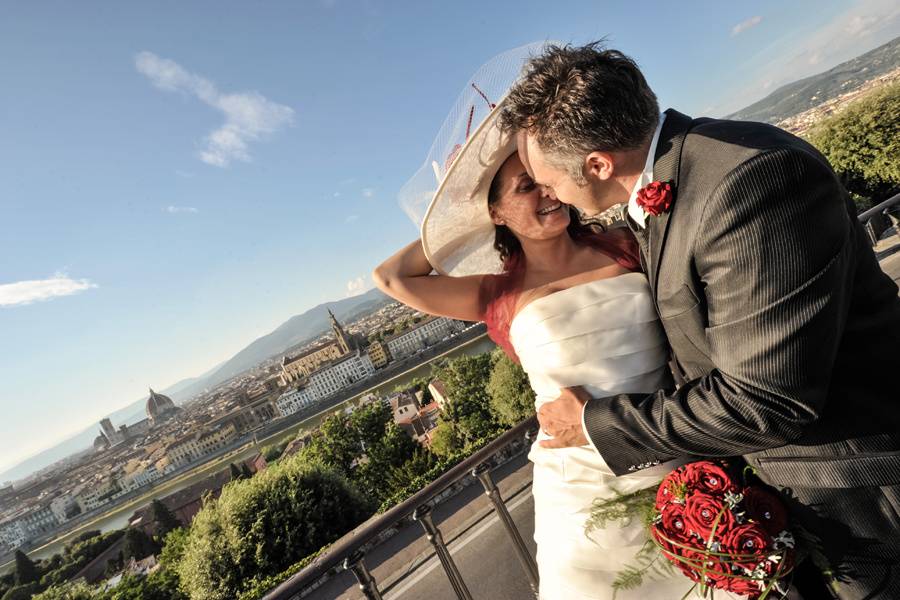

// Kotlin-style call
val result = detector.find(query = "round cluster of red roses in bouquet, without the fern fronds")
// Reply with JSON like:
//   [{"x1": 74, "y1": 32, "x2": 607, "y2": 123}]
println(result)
[{"x1": 650, "y1": 461, "x2": 795, "y2": 600}]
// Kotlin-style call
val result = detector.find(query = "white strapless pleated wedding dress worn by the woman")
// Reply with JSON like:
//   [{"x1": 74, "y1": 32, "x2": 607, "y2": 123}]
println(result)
[{"x1": 510, "y1": 273, "x2": 728, "y2": 600}]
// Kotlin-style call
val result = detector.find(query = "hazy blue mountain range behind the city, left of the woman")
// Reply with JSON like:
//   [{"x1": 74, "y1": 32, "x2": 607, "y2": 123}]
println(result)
[{"x1": 0, "y1": 289, "x2": 392, "y2": 482}]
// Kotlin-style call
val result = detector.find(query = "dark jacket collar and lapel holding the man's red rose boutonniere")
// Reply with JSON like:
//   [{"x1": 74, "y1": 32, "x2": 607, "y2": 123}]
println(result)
[{"x1": 647, "y1": 108, "x2": 692, "y2": 298}]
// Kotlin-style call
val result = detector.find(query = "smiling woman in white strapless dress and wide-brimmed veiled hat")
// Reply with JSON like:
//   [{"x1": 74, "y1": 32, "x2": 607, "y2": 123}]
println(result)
[{"x1": 373, "y1": 74, "x2": 712, "y2": 600}]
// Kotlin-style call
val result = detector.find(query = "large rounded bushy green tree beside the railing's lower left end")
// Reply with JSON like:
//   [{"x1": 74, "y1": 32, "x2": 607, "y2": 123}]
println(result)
[{"x1": 177, "y1": 454, "x2": 371, "y2": 600}]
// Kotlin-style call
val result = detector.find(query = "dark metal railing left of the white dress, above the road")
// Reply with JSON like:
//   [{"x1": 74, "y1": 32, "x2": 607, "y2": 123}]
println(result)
[{"x1": 263, "y1": 417, "x2": 538, "y2": 600}]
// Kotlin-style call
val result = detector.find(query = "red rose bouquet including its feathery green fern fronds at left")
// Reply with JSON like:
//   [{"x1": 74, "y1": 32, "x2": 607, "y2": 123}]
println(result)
[{"x1": 586, "y1": 461, "x2": 800, "y2": 600}]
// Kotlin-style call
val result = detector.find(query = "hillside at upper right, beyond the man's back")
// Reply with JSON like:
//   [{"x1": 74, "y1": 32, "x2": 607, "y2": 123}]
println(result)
[{"x1": 726, "y1": 37, "x2": 900, "y2": 125}]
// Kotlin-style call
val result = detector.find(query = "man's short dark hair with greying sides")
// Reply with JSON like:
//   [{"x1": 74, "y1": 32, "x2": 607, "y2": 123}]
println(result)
[{"x1": 500, "y1": 42, "x2": 659, "y2": 182}]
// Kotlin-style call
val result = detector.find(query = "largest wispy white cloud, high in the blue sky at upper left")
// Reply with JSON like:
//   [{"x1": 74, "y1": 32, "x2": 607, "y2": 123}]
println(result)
[{"x1": 134, "y1": 51, "x2": 294, "y2": 167}]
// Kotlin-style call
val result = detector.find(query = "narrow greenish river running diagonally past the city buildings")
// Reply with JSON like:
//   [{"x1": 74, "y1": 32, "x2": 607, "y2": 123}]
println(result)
[{"x1": 12, "y1": 335, "x2": 495, "y2": 570}]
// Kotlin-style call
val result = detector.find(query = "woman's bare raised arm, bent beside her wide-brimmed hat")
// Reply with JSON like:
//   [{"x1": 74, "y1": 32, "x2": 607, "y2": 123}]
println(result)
[{"x1": 372, "y1": 240, "x2": 484, "y2": 321}]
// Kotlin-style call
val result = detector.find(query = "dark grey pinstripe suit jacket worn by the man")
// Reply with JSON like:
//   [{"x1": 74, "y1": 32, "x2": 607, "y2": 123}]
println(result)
[{"x1": 584, "y1": 111, "x2": 900, "y2": 487}]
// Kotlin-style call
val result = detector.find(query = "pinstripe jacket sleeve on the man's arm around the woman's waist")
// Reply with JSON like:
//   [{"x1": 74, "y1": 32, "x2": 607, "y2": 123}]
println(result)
[{"x1": 583, "y1": 148, "x2": 856, "y2": 474}]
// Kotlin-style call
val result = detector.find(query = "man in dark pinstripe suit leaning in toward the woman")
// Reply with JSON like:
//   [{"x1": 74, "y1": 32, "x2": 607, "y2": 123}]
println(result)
[{"x1": 501, "y1": 44, "x2": 900, "y2": 599}]
